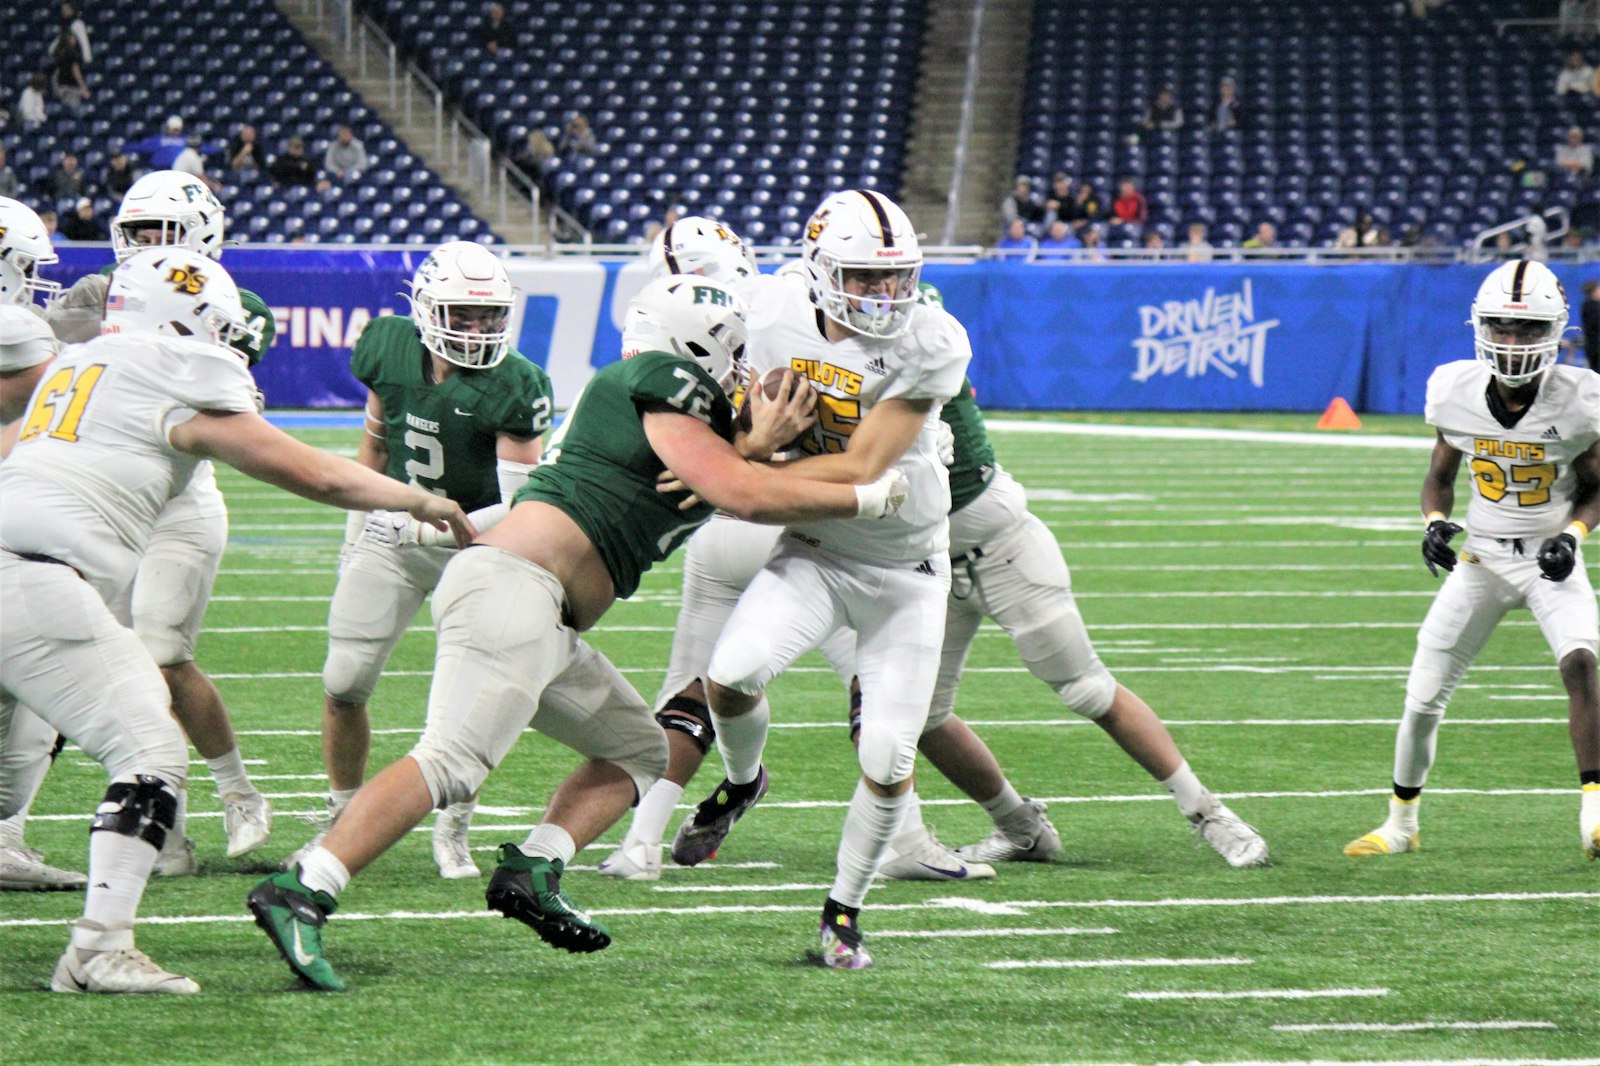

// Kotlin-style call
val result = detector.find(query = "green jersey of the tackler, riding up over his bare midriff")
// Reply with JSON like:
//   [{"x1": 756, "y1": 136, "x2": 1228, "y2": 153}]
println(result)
[{"x1": 515, "y1": 352, "x2": 733, "y2": 599}]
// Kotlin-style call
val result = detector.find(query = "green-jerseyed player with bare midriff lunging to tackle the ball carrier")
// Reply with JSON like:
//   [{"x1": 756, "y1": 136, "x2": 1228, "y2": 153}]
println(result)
[{"x1": 248, "y1": 275, "x2": 906, "y2": 991}]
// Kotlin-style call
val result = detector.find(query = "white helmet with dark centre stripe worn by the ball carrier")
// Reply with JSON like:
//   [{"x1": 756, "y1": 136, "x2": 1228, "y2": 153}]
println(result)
[{"x1": 800, "y1": 189, "x2": 922, "y2": 338}]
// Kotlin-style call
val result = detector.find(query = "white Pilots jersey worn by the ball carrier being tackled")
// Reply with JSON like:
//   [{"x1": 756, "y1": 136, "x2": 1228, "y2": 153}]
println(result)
[{"x1": 739, "y1": 275, "x2": 973, "y2": 565}]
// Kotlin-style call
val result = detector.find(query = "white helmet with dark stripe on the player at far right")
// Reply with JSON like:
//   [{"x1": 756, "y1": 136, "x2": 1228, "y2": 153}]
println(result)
[{"x1": 1472, "y1": 259, "x2": 1566, "y2": 387}]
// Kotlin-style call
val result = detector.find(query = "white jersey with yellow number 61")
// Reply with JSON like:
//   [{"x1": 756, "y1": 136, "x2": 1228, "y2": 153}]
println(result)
[{"x1": 0, "y1": 333, "x2": 256, "y2": 603}]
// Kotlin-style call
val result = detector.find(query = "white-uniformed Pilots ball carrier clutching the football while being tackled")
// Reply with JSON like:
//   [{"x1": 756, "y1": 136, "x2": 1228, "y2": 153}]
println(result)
[{"x1": 672, "y1": 190, "x2": 971, "y2": 970}]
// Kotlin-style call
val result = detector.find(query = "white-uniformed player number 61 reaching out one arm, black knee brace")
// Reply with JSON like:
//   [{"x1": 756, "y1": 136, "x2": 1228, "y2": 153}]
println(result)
[{"x1": 0, "y1": 248, "x2": 474, "y2": 994}]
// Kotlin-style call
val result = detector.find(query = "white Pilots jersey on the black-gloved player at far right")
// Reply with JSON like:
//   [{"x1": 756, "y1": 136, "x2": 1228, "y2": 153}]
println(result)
[{"x1": 1424, "y1": 360, "x2": 1600, "y2": 539}]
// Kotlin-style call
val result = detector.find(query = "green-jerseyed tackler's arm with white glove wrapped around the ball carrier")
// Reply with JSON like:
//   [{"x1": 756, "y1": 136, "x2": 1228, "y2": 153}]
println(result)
[{"x1": 642, "y1": 405, "x2": 906, "y2": 525}]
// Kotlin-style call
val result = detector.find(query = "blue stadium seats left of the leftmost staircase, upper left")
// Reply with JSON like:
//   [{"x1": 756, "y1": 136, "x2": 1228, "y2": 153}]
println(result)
[{"x1": 0, "y1": 0, "x2": 494, "y2": 243}]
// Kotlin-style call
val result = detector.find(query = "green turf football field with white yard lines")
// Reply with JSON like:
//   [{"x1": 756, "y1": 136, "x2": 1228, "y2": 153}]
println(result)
[{"x1": 0, "y1": 416, "x2": 1600, "y2": 1064}]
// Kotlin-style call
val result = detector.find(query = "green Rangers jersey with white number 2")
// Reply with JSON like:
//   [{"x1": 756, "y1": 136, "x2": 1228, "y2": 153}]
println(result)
[{"x1": 350, "y1": 315, "x2": 554, "y2": 511}]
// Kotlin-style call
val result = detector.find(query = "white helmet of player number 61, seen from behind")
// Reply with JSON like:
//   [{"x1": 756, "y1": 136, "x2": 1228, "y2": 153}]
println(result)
[{"x1": 101, "y1": 248, "x2": 250, "y2": 347}]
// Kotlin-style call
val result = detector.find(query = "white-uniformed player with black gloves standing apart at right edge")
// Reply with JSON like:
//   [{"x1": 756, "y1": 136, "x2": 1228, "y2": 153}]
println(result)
[{"x1": 1344, "y1": 259, "x2": 1600, "y2": 860}]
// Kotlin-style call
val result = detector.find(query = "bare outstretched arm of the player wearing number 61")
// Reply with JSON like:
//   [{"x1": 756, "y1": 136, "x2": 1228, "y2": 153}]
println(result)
[{"x1": 166, "y1": 411, "x2": 475, "y2": 546}]
